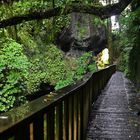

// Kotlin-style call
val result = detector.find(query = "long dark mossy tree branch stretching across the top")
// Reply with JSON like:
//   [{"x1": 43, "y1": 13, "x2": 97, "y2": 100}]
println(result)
[{"x1": 0, "y1": 0, "x2": 132, "y2": 28}]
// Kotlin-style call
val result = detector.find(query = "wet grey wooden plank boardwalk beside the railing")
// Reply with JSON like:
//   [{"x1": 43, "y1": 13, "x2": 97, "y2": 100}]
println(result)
[{"x1": 86, "y1": 72, "x2": 140, "y2": 140}]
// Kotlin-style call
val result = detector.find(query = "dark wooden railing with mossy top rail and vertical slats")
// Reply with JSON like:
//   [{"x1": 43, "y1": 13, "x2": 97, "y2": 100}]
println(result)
[{"x1": 0, "y1": 65, "x2": 116, "y2": 140}]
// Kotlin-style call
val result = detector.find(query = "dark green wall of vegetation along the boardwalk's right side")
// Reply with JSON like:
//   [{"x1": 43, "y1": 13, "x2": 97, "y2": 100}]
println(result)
[{"x1": 113, "y1": 7, "x2": 140, "y2": 90}]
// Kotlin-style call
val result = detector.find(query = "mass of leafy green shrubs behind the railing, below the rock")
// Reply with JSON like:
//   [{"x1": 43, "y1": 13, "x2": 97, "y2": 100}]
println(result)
[{"x1": 0, "y1": 35, "x2": 96, "y2": 111}]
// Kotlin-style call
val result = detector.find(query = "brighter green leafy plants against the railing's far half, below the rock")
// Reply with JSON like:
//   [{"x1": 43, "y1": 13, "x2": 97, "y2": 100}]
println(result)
[{"x1": 55, "y1": 52, "x2": 97, "y2": 90}]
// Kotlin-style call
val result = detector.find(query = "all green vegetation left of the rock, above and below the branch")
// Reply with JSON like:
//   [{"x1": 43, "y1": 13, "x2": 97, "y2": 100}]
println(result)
[{"x1": 0, "y1": 0, "x2": 99, "y2": 112}]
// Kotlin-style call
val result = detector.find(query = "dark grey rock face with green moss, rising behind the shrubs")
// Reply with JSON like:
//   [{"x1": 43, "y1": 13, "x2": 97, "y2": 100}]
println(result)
[{"x1": 57, "y1": 13, "x2": 107, "y2": 56}]
